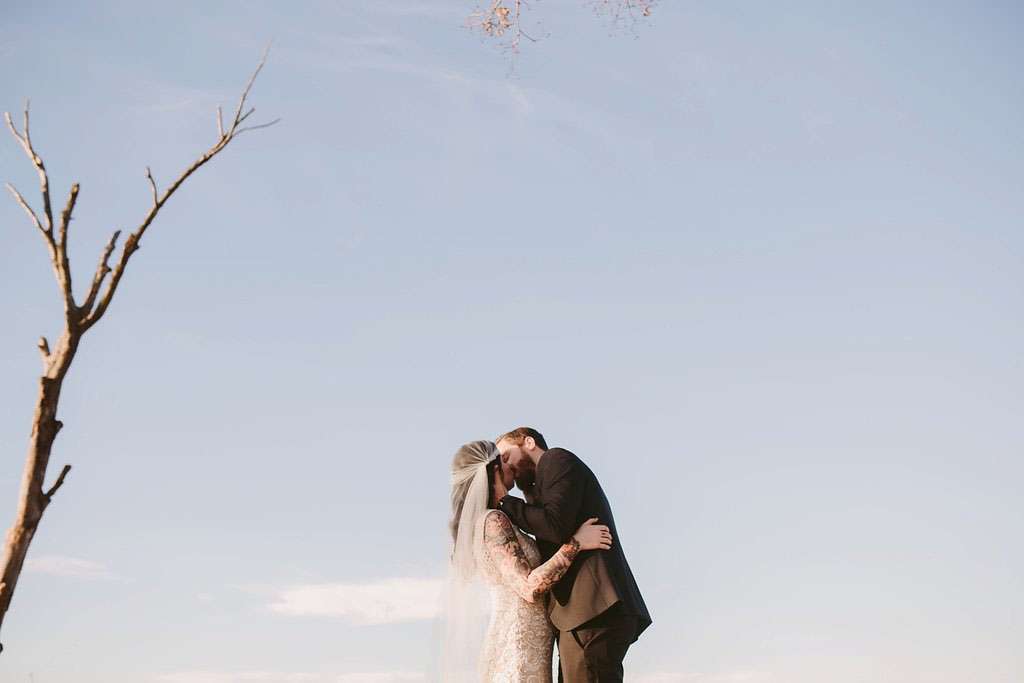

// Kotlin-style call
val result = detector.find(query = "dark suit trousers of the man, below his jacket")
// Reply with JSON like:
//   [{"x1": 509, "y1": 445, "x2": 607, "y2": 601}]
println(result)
[{"x1": 558, "y1": 603, "x2": 639, "y2": 683}]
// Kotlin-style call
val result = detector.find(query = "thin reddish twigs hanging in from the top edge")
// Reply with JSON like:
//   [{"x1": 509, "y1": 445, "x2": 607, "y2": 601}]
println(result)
[{"x1": 466, "y1": 0, "x2": 657, "y2": 53}]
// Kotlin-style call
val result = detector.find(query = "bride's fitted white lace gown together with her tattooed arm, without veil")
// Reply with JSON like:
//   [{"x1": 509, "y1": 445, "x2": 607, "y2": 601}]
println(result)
[{"x1": 476, "y1": 510, "x2": 575, "y2": 683}]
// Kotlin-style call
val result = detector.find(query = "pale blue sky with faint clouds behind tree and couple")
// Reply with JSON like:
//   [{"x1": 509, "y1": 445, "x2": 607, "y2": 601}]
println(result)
[{"x1": 0, "y1": 0, "x2": 1024, "y2": 683}]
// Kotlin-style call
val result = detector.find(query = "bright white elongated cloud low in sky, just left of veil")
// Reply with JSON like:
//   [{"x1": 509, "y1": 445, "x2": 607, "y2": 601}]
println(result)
[{"x1": 270, "y1": 579, "x2": 441, "y2": 625}]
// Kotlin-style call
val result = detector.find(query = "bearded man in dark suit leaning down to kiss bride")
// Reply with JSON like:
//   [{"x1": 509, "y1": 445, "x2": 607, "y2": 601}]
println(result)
[{"x1": 497, "y1": 427, "x2": 651, "y2": 683}]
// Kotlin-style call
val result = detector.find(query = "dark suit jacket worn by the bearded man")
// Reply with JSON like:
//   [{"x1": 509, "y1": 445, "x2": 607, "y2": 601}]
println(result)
[{"x1": 499, "y1": 449, "x2": 651, "y2": 637}]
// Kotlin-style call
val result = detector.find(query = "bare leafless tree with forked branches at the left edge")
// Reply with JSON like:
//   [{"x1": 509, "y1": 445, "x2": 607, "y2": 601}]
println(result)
[{"x1": 0, "y1": 51, "x2": 279, "y2": 650}]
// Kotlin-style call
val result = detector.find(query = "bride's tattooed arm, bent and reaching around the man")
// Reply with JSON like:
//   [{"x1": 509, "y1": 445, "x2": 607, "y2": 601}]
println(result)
[{"x1": 483, "y1": 510, "x2": 580, "y2": 602}]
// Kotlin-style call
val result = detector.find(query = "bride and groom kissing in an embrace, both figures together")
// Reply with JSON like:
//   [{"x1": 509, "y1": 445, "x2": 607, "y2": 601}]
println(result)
[{"x1": 441, "y1": 427, "x2": 651, "y2": 683}]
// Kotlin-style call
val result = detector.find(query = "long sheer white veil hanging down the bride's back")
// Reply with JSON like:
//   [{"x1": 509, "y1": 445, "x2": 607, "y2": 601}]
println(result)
[{"x1": 440, "y1": 441, "x2": 498, "y2": 683}]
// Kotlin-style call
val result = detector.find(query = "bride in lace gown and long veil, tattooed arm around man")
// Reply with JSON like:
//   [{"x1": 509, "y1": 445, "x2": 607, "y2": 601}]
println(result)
[{"x1": 441, "y1": 441, "x2": 611, "y2": 683}]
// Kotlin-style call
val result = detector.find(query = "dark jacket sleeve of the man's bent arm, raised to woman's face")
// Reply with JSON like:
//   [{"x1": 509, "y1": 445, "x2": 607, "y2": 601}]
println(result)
[{"x1": 501, "y1": 453, "x2": 584, "y2": 544}]
